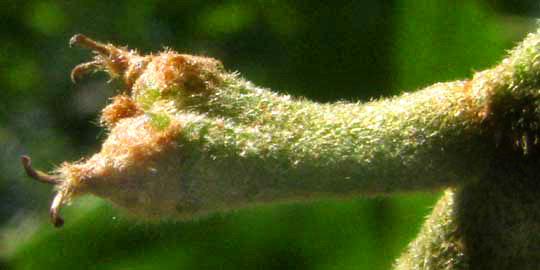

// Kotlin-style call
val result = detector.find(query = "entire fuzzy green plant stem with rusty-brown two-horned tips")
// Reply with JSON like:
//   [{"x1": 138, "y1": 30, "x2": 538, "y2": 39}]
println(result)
[{"x1": 23, "y1": 28, "x2": 540, "y2": 270}]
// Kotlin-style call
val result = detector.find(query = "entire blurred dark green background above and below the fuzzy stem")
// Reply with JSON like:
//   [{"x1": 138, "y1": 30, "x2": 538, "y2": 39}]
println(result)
[{"x1": 0, "y1": 0, "x2": 540, "y2": 270}]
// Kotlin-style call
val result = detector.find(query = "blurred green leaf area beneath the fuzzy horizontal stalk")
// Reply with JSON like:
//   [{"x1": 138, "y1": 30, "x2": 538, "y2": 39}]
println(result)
[{"x1": 11, "y1": 194, "x2": 436, "y2": 269}]
